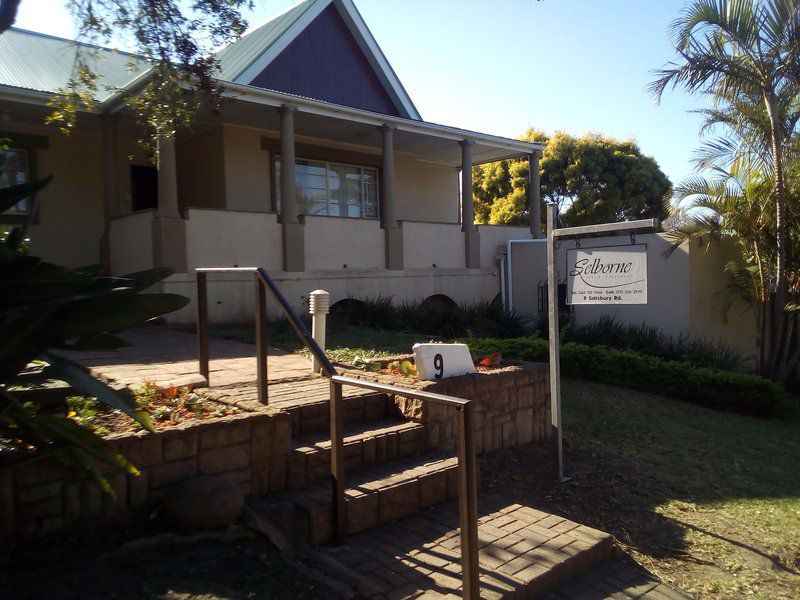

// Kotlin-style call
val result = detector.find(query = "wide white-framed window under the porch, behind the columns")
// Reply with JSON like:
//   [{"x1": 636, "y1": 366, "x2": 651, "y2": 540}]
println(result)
[{"x1": 275, "y1": 157, "x2": 379, "y2": 219}]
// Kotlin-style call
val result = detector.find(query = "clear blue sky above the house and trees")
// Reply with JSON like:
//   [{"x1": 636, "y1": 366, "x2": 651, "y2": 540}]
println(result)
[{"x1": 17, "y1": 0, "x2": 701, "y2": 183}]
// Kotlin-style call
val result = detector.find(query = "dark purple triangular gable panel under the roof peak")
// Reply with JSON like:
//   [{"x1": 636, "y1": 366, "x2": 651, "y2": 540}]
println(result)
[{"x1": 251, "y1": 4, "x2": 401, "y2": 116}]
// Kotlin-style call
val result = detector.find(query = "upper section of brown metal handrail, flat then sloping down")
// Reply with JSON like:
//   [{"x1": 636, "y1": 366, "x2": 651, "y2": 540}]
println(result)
[{"x1": 195, "y1": 267, "x2": 337, "y2": 404}]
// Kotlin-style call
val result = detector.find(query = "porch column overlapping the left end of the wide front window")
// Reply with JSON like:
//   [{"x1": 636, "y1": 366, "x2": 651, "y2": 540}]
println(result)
[{"x1": 280, "y1": 104, "x2": 306, "y2": 271}]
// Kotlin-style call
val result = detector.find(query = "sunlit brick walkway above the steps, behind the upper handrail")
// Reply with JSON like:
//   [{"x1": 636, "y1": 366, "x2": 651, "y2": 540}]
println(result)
[{"x1": 54, "y1": 325, "x2": 311, "y2": 388}]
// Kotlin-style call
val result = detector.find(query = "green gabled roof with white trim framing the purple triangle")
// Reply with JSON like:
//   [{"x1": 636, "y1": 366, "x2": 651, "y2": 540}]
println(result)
[{"x1": 217, "y1": 0, "x2": 422, "y2": 120}]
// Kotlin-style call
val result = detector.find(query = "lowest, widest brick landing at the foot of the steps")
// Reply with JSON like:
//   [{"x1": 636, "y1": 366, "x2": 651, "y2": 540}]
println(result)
[{"x1": 320, "y1": 494, "x2": 612, "y2": 599}]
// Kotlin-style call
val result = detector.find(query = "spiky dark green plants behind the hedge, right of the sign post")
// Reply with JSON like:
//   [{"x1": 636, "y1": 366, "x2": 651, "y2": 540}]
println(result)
[{"x1": 564, "y1": 315, "x2": 742, "y2": 371}]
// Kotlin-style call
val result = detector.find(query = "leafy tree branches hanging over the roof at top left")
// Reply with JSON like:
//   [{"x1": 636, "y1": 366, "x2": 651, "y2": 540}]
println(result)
[{"x1": 0, "y1": 0, "x2": 252, "y2": 145}]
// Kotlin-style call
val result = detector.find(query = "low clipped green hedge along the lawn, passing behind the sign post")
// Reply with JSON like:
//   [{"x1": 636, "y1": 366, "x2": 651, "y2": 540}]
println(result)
[{"x1": 466, "y1": 337, "x2": 797, "y2": 417}]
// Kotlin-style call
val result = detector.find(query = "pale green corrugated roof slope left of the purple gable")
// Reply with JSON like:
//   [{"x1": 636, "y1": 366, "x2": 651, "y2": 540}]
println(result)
[{"x1": 217, "y1": 0, "x2": 314, "y2": 81}]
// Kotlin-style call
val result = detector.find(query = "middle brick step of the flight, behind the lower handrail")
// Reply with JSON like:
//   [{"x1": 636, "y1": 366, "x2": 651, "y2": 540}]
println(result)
[{"x1": 286, "y1": 419, "x2": 425, "y2": 490}]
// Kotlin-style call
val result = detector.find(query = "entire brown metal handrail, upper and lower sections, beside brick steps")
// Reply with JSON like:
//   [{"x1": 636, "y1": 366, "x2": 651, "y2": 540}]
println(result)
[{"x1": 195, "y1": 267, "x2": 480, "y2": 600}]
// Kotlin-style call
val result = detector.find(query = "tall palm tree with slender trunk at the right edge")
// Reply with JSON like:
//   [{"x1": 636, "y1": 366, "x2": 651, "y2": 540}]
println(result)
[{"x1": 651, "y1": 0, "x2": 800, "y2": 377}]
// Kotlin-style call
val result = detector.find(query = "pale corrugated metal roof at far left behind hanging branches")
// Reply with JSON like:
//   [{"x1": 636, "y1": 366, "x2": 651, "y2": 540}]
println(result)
[{"x1": 0, "y1": 28, "x2": 147, "y2": 102}]
